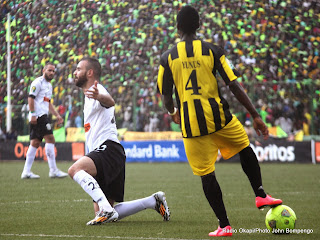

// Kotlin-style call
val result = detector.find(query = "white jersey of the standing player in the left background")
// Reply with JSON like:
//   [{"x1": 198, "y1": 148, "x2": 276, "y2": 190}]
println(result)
[{"x1": 29, "y1": 76, "x2": 52, "y2": 121}]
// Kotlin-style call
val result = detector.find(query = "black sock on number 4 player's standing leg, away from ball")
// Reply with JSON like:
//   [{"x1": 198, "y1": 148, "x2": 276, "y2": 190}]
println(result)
[{"x1": 201, "y1": 172, "x2": 230, "y2": 228}]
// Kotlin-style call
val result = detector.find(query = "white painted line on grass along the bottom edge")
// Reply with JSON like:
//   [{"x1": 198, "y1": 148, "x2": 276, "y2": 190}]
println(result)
[{"x1": 0, "y1": 233, "x2": 209, "y2": 240}]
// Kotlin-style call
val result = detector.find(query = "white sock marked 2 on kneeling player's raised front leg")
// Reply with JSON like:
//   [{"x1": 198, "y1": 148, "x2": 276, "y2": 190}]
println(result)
[{"x1": 73, "y1": 170, "x2": 113, "y2": 212}]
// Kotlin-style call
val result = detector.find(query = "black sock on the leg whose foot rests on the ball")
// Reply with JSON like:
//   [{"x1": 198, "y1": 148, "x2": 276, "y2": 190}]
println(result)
[{"x1": 239, "y1": 147, "x2": 266, "y2": 198}]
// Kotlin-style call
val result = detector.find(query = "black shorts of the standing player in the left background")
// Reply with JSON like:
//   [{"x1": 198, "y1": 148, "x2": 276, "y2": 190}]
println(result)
[{"x1": 29, "y1": 114, "x2": 53, "y2": 142}]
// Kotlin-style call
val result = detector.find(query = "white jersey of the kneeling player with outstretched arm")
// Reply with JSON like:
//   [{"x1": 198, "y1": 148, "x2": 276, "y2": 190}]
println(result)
[{"x1": 83, "y1": 84, "x2": 120, "y2": 152}]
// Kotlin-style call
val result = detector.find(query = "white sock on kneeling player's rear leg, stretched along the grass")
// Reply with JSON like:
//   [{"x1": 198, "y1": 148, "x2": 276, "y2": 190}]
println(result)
[{"x1": 114, "y1": 196, "x2": 156, "y2": 220}]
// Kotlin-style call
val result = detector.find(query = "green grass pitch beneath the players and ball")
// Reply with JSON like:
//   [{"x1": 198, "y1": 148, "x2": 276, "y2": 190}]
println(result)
[{"x1": 0, "y1": 161, "x2": 320, "y2": 240}]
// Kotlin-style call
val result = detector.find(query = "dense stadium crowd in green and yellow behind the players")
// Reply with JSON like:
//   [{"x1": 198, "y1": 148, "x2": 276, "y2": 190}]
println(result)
[{"x1": 0, "y1": 0, "x2": 320, "y2": 138}]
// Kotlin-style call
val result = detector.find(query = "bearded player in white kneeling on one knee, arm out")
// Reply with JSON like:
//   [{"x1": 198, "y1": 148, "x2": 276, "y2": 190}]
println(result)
[{"x1": 68, "y1": 58, "x2": 170, "y2": 225}]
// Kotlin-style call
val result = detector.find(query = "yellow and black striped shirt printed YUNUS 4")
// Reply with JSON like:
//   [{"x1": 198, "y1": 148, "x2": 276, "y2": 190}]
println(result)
[{"x1": 158, "y1": 40, "x2": 239, "y2": 138}]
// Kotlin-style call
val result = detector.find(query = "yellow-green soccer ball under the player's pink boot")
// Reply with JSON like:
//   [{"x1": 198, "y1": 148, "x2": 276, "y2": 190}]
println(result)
[{"x1": 265, "y1": 205, "x2": 297, "y2": 233}]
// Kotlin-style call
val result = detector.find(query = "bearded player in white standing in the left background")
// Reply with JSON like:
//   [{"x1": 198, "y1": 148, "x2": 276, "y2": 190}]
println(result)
[{"x1": 21, "y1": 63, "x2": 68, "y2": 179}]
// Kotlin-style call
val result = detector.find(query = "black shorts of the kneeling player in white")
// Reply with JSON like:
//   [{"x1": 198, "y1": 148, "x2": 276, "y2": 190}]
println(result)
[{"x1": 86, "y1": 140, "x2": 126, "y2": 202}]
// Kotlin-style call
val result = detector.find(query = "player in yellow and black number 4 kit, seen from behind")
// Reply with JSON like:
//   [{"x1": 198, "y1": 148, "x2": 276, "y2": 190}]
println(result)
[{"x1": 157, "y1": 5, "x2": 282, "y2": 236}]
